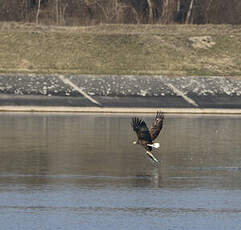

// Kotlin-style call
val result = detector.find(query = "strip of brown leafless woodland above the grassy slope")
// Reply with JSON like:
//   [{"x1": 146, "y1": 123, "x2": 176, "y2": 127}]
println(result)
[{"x1": 0, "y1": 0, "x2": 241, "y2": 25}]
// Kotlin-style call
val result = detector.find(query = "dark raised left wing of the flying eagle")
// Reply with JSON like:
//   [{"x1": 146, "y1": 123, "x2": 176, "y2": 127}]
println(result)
[{"x1": 131, "y1": 117, "x2": 152, "y2": 143}]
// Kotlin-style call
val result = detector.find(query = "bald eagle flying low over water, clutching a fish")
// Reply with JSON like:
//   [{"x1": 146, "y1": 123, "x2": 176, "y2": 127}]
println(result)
[{"x1": 131, "y1": 111, "x2": 164, "y2": 163}]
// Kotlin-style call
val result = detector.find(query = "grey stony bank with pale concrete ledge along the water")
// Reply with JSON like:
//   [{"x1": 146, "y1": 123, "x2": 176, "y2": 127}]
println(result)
[{"x1": 0, "y1": 74, "x2": 241, "y2": 114}]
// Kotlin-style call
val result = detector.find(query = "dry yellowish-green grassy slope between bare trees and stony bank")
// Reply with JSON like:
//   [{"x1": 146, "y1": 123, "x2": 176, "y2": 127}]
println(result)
[{"x1": 0, "y1": 22, "x2": 241, "y2": 76}]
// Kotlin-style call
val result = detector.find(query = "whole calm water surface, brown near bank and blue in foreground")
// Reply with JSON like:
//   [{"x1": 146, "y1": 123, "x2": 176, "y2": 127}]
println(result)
[{"x1": 0, "y1": 113, "x2": 241, "y2": 230}]
